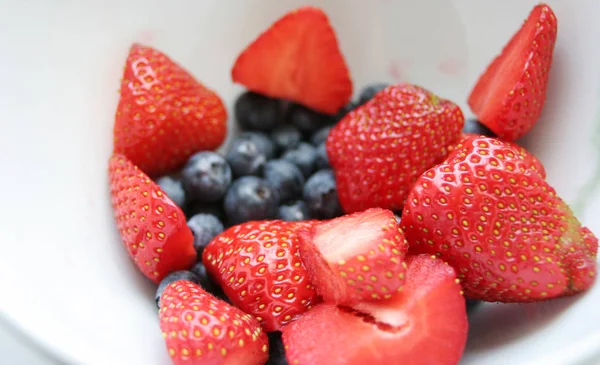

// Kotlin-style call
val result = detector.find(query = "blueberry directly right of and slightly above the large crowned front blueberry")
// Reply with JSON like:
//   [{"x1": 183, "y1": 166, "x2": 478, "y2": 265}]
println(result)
[{"x1": 264, "y1": 160, "x2": 304, "y2": 202}]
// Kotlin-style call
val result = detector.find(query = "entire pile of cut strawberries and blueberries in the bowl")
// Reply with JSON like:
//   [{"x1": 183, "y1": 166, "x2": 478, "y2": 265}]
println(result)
[{"x1": 109, "y1": 4, "x2": 598, "y2": 365}]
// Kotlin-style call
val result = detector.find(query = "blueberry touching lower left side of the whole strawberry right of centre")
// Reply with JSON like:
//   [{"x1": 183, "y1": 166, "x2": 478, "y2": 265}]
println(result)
[{"x1": 304, "y1": 169, "x2": 342, "y2": 219}]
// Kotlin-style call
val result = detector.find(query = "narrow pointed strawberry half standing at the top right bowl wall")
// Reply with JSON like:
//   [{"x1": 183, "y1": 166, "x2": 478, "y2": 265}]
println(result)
[{"x1": 469, "y1": 4, "x2": 557, "y2": 141}]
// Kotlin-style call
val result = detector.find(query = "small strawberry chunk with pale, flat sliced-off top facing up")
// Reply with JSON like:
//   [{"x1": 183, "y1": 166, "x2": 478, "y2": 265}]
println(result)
[{"x1": 299, "y1": 208, "x2": 408, "y2": 304}]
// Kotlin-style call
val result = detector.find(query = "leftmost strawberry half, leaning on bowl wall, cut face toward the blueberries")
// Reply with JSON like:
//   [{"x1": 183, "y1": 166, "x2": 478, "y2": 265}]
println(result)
[{"x1": 108, "y1": 154, "x2": 196, "y2": 283}]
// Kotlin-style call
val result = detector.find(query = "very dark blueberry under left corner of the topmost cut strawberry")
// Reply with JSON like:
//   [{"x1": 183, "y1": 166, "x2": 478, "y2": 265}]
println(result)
[{"x1": 234, "y1": 91, "x2": 283, "y2": 131}]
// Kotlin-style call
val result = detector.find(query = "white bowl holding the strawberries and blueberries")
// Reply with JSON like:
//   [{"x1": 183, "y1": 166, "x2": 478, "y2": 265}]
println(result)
[{"x1": 0, "y1": 0, "x2": 600, "y2": 365}]
